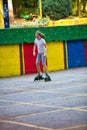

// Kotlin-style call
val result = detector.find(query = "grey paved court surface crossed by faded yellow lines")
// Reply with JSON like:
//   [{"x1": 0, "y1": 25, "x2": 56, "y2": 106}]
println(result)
[{"x1": 0, "y1": 67, "x2": 87, "y2": 130}]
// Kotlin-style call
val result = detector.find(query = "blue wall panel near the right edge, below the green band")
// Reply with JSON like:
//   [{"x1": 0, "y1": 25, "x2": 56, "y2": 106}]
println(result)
[{"x1": 68, "y1": 40, "x2": 86, "y2": 68}]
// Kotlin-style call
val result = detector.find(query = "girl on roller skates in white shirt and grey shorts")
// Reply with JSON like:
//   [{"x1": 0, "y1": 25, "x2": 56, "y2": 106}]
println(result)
[{"x1": 33, "y1": 31, "x2": 51, "y2": 81}]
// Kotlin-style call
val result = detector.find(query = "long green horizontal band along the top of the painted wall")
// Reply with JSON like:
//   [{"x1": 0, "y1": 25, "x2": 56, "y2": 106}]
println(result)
[{"x1": 0, "y1": 25, "x2": 87, "y2": 44}]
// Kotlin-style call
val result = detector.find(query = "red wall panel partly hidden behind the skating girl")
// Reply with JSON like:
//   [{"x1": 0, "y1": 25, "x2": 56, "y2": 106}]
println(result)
[{"x1": 23, "y1": 44, "x2": 42, "y2": 74}]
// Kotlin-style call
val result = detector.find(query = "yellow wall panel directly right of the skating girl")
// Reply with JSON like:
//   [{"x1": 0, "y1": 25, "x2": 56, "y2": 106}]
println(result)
[{"x1": 47, "y1": 42, "x2": 64, "y2": 71}]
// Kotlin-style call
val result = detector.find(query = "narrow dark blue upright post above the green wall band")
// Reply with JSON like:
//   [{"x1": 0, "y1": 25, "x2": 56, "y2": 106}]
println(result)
[{"x1": 3, "y1": 0, "x2": 9, "y2": 28}]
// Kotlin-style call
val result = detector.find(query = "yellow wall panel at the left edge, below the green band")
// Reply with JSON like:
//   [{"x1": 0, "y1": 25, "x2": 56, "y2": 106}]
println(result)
[{"x1": 0, "y1": 45, "x2": 20, "y2": 77}]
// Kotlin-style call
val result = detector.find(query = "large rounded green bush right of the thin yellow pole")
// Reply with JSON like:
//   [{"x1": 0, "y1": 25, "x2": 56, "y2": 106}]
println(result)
[{"x1": 42, "y1": 0, "x2": 72, "y2": 20}]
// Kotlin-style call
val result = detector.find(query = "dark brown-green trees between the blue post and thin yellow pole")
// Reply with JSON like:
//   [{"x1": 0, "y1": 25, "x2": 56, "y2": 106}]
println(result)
[{"x1": 12, "y1": 0, "x2": 38, "y2": 18}]
